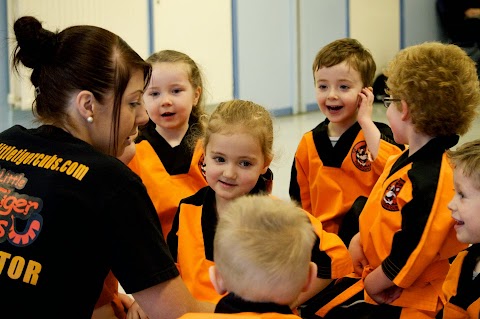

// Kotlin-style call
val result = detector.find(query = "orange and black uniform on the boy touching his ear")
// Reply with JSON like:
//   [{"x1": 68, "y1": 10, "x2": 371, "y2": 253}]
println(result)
[{"x1": 289, "y1": 119, "x2": 403, "y2": 245}]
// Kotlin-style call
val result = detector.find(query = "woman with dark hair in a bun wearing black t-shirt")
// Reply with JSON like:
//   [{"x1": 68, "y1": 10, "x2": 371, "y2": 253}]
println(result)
[{"x1": 0, "y1": 17, "x2": 213, "y2": 319}]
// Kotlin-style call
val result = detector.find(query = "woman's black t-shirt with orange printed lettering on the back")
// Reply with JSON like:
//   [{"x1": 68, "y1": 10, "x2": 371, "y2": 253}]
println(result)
[{"x1": 0, "y1": 125, "x2": 178, "y2": 318}]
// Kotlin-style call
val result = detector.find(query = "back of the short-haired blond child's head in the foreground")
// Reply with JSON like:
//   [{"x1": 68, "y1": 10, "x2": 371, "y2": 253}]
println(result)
[{"x1": 210, "y1": 196, "x2": 317, "y2": 305}]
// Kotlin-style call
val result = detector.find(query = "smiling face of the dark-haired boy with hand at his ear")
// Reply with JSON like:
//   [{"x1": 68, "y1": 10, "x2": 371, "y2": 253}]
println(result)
[{"x1": 314, "y1": 61, "x2": 363, "y2": 134}]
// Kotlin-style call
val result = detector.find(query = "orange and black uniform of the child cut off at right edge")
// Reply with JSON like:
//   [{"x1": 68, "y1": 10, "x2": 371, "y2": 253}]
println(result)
[{"x1": 437, "y1": 244, "x2": 480, "y2": 319}]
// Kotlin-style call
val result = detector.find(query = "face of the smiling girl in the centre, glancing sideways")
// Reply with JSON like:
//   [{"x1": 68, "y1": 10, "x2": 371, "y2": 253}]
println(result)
[{"x1": 205, "y1": 132, "x2": 270, "y2": 202}]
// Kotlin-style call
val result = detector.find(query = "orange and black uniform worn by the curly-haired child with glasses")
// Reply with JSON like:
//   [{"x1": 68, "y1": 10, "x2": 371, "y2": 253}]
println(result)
[{"x1": 304, "y1": 136, "x2": 466, "y2": 318}]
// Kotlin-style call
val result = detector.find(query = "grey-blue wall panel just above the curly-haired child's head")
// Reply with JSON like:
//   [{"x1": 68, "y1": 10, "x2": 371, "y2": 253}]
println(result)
[{"x1": 400, "y1": 0, "x2": 443, "y2": 48}]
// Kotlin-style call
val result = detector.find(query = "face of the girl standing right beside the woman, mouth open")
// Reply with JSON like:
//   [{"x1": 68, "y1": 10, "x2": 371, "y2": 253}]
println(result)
[{"x1": 144, "y1": 62, "x2": 201, "y2": 134}]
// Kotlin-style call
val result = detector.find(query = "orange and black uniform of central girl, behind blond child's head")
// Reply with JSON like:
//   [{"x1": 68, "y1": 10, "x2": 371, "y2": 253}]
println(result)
[{"x1": 167, "y1": 176, "x2": 353, "y2": 303}]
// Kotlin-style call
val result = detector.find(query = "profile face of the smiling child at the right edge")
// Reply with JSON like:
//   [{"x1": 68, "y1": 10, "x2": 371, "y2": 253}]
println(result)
[{"x1": 448, "y1": 167, "x2": 480, "y2": 244}]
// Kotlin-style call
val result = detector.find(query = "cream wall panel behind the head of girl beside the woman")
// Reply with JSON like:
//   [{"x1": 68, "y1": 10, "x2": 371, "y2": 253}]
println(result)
[{"x1": 153, "y1": 0, "x2": 233, "y2": 104}]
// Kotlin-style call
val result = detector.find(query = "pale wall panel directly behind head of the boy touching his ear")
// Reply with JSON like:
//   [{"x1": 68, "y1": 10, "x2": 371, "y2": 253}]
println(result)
[{"x1": 298, "y1": 0, "x2": 349, "y2": 112}]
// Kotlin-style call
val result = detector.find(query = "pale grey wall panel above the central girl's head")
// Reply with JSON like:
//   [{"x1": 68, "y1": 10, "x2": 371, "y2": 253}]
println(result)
[{"x1": 232, "y1": 0, "x2": 296, "y2": 114}]
